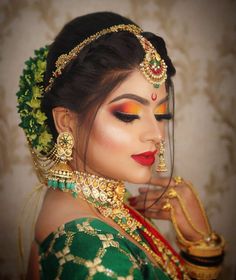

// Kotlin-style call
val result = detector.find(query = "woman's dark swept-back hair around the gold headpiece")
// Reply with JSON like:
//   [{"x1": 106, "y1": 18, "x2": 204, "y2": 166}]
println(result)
[{"x1": 42, "y1": 12, "x2": 175, "y2": 166}]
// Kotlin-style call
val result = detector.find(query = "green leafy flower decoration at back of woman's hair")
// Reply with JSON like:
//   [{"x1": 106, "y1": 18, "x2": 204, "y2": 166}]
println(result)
[{"x1": 16, "y1": 46, "x2": 53, "y2": 155}]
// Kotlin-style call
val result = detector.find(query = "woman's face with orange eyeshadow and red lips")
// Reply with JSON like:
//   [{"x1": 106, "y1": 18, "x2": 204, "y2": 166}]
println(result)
[{"x1": 77, "y1": 70, "x2": 169, "y2": 183}]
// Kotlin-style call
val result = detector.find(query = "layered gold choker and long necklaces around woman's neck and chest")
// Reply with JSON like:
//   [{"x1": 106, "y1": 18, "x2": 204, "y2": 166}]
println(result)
[{"x1": 49, "y1": 171, "x2": 189, "y2": 279}]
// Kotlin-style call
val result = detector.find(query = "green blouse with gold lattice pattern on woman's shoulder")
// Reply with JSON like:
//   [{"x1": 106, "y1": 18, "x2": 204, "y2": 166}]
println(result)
[{"x1": 39, "y1": 218, "x2": 170, "y2": 280}]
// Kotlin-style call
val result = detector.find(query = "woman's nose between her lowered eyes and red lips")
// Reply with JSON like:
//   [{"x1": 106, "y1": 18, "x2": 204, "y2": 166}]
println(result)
[{"x1": 140, "y1": 118, "x2": 165, "y2": 145}]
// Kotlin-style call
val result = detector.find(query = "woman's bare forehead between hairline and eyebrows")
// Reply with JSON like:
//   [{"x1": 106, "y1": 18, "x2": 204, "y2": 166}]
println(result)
[{"x1": 105, "y1": 70, "x2": 167, "y2": 103}]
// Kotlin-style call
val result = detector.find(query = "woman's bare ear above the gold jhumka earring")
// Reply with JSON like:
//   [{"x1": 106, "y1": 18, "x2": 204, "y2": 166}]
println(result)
[{"x1": 52, "y1": 107, "x2": 76, "y2": 134}]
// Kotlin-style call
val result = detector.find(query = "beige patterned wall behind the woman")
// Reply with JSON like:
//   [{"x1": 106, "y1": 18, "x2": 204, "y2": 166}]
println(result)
[{"x1": 0, "y1": 0, "x2": 236, "y2": 279}]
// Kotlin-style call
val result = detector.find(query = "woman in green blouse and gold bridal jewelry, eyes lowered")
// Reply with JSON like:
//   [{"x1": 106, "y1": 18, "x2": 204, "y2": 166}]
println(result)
[{"x1": 18, "y1": 12, "x2": 223, "y2": 279}]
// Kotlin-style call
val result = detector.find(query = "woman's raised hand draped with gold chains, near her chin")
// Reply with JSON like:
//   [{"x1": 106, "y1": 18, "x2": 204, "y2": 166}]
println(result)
[{"x1": 129, "y1": 178, "x2": 211, "y2": 241}]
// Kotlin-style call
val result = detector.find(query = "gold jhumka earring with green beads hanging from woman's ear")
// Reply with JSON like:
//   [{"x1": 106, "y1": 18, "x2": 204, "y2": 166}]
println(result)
[{"x1": 48, "y1": 132, "x2": 76, "y2": 191}]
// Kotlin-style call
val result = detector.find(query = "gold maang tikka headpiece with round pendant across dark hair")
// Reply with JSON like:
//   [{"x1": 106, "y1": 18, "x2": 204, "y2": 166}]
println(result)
[{"x1": 45, "y1": 24, "x2": 167, "y2": 92}]
